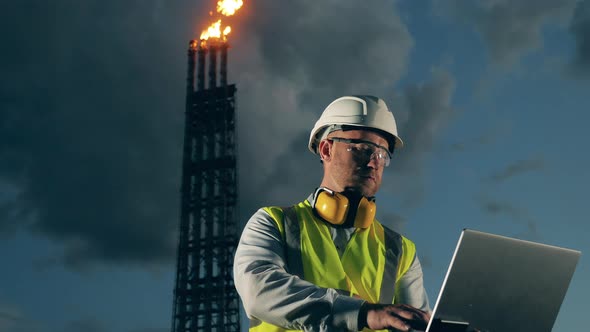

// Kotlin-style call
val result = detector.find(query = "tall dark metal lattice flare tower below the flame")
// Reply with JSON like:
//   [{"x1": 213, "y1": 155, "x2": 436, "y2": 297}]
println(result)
[{"x1": 172, "y1": 41, "x2": 240, "y2": 332}]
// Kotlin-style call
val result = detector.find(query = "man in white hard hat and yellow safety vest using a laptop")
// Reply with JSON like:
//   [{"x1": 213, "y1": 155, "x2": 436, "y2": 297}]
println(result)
[{"x1": 234, "y1": 96, "x2": 430, "y2": 331}]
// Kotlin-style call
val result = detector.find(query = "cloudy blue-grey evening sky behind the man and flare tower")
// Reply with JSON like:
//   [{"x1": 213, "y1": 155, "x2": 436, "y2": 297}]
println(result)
[{"x1": 0, "y1": 0, "x2": 590, "y2": 332}]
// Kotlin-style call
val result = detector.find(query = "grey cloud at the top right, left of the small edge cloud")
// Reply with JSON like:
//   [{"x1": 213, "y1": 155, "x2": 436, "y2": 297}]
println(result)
[{"x1": 435, "y1": 0, "x2": 576, "y2": 65}]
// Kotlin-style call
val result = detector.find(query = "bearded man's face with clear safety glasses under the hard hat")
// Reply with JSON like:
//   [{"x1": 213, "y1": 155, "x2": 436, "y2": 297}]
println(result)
[{"x1": 319, "y1": 130, "x2": 389, "y2": 197}]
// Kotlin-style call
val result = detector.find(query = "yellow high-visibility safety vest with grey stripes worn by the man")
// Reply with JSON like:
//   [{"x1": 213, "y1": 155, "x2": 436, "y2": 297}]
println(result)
[{"x1": 250, "y1": 200, "x2": 416, "y2": 332}]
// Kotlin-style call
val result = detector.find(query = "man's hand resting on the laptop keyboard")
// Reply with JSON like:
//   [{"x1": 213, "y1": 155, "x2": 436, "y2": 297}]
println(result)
[{"x1": 359, "y1": 303, "x2": 430, "y2": 331}]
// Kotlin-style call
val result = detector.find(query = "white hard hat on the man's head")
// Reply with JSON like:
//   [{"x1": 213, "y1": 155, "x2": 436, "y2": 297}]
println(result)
[{"x1": 308, "y1": 96, "x2": 404, "y2": 154}]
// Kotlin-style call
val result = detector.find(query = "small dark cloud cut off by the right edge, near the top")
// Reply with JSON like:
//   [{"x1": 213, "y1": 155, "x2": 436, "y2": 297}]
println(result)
[{"x1": 569, "y1": 0, "x2": 590, "y2": 78}]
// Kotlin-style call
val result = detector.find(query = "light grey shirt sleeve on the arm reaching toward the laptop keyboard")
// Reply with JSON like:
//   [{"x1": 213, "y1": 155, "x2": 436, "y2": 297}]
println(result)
[{"x1": 234, "y1": 209, "x2": 364, "y2": 332}]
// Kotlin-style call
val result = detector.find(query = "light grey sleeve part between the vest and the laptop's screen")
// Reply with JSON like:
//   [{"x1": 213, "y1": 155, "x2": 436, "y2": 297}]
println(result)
[{"x1": 395, "y1": 255, "x2": 432, "y2": 312}]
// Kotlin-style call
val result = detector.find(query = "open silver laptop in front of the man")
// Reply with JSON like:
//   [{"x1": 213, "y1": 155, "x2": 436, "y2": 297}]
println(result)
[{"x1": 426, "y1": 229, "x2": 581, "y2": 332}]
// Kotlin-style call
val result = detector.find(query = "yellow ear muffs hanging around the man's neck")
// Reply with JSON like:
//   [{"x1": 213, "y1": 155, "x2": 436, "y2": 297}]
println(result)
[{"x1": 312, "y1": 188, "x2": 377, "y2": 228}]
